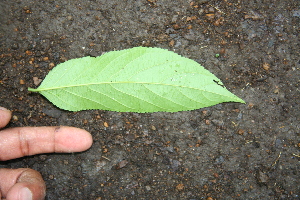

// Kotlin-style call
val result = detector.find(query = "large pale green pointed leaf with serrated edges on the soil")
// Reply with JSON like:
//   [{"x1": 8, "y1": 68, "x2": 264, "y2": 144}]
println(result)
[{"x1": 29, "y1": 47, "x2": 245, "y2": 113}]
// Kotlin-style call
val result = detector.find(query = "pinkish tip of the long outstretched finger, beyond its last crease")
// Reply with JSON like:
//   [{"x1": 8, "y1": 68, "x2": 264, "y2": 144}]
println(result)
[{"x1": 55, "y1": 126, "x2": 93, "y2": 153}]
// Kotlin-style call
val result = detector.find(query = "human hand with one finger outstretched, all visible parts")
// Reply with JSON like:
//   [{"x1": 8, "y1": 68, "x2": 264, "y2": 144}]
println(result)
[{"x1": 0, "y1": 107, "x2": 93, "y2": 200}]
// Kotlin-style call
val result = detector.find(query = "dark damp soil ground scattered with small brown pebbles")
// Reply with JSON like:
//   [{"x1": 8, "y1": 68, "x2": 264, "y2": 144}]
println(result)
[{"x1": 0, "y1": 0, "x2": 300, "y2": 200}]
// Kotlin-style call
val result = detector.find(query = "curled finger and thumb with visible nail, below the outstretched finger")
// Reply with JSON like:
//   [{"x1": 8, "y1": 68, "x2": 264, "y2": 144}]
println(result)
[{"x1": 0, "y1": 168, "x2": 46, "y2": 200}]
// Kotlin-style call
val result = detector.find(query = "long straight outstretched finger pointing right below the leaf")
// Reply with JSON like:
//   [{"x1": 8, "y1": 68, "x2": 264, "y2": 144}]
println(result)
[{"x1": 0, "y1": 126, "x2": 93, "y2": 161}]
